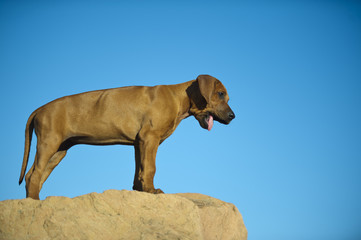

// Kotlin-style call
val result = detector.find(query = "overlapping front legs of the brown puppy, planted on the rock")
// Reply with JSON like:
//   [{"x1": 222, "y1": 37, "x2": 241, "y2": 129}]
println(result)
[{"x1": 133, "y1": 134, "x2": 163, "y2": 193}]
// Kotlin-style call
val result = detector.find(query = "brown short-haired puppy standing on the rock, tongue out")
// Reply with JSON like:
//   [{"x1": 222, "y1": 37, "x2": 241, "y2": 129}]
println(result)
[{"x1": 19, "y1": 75, "x2": 235, "y2": 199}]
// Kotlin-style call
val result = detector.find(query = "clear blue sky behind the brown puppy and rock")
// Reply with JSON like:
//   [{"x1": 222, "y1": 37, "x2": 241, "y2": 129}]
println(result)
[{"x1": 0, "y1": 0, "x2": 361, "y2": 240}]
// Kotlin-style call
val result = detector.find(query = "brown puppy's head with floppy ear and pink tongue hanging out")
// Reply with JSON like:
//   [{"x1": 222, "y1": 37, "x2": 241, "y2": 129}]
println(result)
[{"x1": 187, "y1": 75, "x2": 235, "y2": 130}]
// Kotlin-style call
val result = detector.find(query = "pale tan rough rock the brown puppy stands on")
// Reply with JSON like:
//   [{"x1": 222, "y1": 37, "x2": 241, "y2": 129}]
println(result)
[{"x1": 0, "y1": 190, "x2": 247, "y2": 240}]
